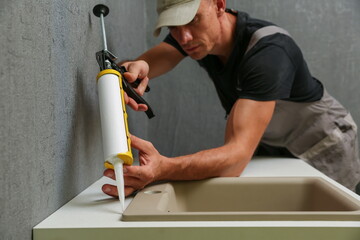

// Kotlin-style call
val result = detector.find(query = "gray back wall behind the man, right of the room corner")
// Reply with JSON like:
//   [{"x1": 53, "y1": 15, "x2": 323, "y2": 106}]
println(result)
[{"x1": 146, "y1": 0, "x2": 360, "y2": 156}]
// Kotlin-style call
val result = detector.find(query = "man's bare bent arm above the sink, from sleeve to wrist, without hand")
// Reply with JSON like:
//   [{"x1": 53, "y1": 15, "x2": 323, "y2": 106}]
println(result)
[{"x1": 159, "y1": 99, "x2": 275, "y2": 180}]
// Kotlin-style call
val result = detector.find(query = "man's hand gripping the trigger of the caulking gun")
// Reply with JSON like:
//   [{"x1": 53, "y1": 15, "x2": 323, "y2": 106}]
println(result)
[{"x1": 121, "y1": 60, "x2": 149, "y2": 111}]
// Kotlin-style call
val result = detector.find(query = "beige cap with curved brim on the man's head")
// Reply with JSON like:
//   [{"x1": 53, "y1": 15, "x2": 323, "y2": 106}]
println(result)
[{"x1": 153, "y1": 0, "x2": 201, "y2": 37}]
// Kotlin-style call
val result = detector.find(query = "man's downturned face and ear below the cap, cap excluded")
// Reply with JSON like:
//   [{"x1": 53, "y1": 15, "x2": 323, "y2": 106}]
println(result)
[{"x1": 169, "y1": 0, "x2": 221, "y2": 60}]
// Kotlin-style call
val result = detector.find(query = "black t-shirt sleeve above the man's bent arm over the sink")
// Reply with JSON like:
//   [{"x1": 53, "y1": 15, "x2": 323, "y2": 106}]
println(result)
[{"x1": 238, "y1": 45, "x2": 295, "y2": 101}]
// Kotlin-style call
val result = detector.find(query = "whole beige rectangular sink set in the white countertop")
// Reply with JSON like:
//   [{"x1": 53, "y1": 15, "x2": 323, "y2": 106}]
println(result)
[{"x1": 122, "y1": 177, "x2": 360, "y2": 221}]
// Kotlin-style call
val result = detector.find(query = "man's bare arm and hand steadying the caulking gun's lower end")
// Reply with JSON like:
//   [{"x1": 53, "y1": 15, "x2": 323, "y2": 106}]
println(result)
[{"x1": 103, "y1": 99, "x2": 275, "y2": 196}]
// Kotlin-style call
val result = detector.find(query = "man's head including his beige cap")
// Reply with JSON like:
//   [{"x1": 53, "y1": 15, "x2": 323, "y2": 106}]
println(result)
[{"x1": 154, "y1": 0, "x2": 225, "y2": 60}]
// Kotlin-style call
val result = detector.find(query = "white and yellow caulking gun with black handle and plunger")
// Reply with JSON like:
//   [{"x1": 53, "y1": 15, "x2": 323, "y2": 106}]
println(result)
[{"x1": 93, "y1": 4, "x2": 154, "y2": 210}]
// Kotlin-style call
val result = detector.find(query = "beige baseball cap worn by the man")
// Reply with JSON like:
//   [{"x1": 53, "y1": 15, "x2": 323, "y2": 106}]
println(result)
[{"x1": 154, "y1": 0, "x2": 201, "y2": 37}]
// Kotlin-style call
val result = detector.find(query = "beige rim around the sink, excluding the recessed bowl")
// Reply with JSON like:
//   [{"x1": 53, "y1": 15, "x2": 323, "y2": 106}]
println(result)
[{"x1": 122, "y1": 177, "x2": 360, "y2": 221}]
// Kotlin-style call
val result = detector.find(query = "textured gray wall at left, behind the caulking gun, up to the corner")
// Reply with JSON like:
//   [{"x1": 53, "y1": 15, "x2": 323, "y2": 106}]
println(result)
[{"x1": 0, "y1": 0, "x2": 145, "y2": 240}]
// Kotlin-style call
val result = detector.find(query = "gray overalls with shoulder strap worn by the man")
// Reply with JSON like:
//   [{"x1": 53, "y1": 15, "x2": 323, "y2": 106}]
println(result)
[{"x1": 247, "y1": 26, "x2": 360, "y2": 190}]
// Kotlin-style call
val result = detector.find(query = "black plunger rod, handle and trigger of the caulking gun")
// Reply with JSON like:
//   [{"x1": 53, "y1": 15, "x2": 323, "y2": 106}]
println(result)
[{"x1": 93, "y1": 4, "x2": 155, "y2": 118}]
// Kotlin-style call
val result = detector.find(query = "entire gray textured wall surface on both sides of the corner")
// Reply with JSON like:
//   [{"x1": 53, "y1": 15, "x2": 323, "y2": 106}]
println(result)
[{"x1": 0, "y1": 0, "x2": 360, "y2": 240}]
